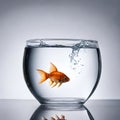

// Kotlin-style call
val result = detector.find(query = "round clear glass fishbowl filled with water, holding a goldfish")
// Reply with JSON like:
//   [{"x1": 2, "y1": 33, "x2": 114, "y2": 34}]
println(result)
[{"x1": 23, "y1": 39, "x2": 101, "y2": 104}]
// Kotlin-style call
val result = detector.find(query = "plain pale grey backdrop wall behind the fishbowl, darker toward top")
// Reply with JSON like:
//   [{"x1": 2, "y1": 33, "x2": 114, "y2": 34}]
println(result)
[{"x1": 0, "y1": 0, "x2": 120, "y2": 99}]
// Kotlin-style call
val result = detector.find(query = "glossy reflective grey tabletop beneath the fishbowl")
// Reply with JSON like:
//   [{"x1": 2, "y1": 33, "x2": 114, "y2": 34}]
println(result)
[{"x1": 0, "y1": 100, "x2": 120, "y2": 120}]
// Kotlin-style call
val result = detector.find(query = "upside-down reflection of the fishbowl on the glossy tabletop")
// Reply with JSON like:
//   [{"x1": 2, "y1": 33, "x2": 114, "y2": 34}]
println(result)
[{"x1": 30, "y1": 104, "x2": 94, "y2": 120}]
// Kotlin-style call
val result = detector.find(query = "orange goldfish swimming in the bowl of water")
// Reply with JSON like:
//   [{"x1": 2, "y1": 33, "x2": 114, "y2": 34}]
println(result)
[{"x1": 37, "y1": 63, "x2": 70, "y2": 87}]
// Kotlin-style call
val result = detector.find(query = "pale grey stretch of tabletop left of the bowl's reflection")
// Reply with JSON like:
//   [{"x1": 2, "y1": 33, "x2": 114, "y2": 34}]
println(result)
[{"x1": 0, "y1": 100, "x2": 40, "y2": 120}]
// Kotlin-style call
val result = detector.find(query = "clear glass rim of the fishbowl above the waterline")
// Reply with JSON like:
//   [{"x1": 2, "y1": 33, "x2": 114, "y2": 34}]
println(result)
[{"x1": 26, "y1": 38, "x2": 98, "y2": 48}]
